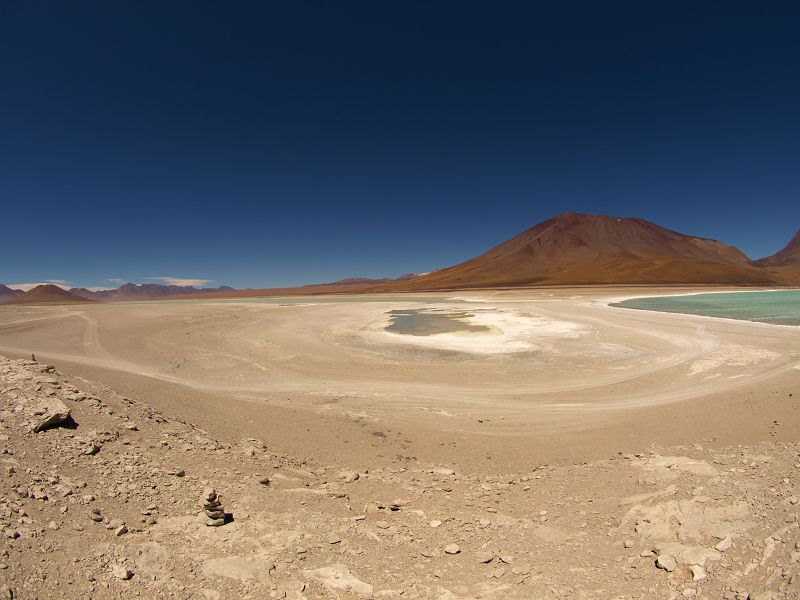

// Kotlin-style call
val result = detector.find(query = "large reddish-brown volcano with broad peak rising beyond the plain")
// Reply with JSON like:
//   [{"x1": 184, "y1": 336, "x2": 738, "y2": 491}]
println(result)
[{"x1": 392, "y1": 213, "x2": 776, "y2": 290}]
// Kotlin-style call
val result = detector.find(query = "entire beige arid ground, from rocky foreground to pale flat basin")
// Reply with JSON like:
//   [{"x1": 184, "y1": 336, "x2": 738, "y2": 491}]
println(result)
[{"x1": 0, "y1": 287, "x2": 800, "y2": 600}]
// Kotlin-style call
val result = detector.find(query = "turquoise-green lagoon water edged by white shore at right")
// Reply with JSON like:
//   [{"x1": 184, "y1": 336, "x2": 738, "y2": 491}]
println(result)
[{"x1": 611, "y1": 290, "x2": 800, "y2": 325}]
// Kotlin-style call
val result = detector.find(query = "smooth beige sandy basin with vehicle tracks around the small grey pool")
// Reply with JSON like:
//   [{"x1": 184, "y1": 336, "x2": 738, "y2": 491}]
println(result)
[{"x1": 0, "y1": 288, "x2": 800, "y2": 471}]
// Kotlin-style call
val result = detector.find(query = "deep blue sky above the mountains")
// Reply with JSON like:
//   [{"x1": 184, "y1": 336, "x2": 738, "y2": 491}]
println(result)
[{"x1": 0, "y1": 0, "x2": 800, "y2": 287}]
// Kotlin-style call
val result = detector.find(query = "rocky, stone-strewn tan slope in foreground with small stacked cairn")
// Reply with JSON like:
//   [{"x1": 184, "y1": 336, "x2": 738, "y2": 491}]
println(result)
[{"x1": 0, "y1": 358, "x2": 800, "y2": 600}]
